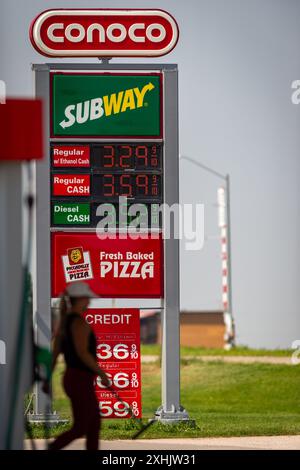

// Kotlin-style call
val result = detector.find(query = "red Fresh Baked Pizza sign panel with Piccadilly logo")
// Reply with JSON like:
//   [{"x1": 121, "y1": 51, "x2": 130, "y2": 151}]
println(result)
[{"x1": 51, "y1": 232, "x2": 163, "y2": 298}]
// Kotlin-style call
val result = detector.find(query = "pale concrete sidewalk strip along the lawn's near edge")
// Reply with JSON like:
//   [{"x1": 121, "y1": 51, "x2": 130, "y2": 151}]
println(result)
[{"x1": 24, "y1": 435, "x2": 300, "y2": 450}]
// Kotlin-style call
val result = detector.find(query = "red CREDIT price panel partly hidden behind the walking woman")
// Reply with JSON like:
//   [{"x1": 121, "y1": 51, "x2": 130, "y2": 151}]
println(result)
[{"x1": 85, "y1": 308, "x2": 142, "y2": 418}]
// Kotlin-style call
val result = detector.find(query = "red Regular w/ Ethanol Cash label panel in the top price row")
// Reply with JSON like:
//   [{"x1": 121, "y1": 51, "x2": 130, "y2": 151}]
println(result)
[{"x1": 52, "y1": 145, "x2": 90, "y2": 168}]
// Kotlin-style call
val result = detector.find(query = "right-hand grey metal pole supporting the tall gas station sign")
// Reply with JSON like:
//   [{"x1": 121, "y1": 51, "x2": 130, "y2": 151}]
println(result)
[{"x1": 156, "y1": 65, "x2": 189, "y2": 423}]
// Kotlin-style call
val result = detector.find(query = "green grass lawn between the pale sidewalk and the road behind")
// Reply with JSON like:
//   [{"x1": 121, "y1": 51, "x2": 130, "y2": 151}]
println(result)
[{"x1": 26, "y1": 359, "x2": 300, "y2": 439}]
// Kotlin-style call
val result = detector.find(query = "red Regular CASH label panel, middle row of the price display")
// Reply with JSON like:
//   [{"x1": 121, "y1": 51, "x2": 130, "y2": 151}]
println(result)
[{"x1": 52, "y1": 173, "x2": 90, "y2": 196}]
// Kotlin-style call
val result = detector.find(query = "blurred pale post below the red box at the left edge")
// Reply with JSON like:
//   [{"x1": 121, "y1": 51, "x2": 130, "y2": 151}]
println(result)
[{"x1": 0, "y1": 162, "x2": 26, "y2": 450}]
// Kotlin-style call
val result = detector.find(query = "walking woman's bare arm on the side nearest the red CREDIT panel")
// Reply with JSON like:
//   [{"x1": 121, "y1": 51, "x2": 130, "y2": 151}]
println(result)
[{"x1": 71, "y1": 318, "x2": 109, "y2": 387}]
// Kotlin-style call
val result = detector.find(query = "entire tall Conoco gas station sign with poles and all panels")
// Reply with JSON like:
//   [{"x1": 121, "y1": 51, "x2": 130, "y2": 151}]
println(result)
[{"x1": 34, "y1": 9, "x2": 180, "y2": 426}]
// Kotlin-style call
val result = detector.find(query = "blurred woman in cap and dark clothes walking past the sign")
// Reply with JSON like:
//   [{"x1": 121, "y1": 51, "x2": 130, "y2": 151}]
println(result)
[{"x1": 49, "y1": 282, "x2": 109, "y2": 450}]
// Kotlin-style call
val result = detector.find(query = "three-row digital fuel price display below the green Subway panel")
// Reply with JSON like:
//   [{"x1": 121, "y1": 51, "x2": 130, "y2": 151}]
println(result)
[{"x1": 50, "y1": 141, "x2": 163, "y2": 228}]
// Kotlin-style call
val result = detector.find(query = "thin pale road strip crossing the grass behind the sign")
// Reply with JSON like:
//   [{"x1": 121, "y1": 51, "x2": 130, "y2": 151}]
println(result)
[{"x1": 141, "y1": 355, "x2": 293, "y2": 365}]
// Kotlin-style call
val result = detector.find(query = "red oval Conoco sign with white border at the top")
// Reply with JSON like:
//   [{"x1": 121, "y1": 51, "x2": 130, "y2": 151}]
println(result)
[{"x1": 30, "y1": 9, "x2": 179, "y2": 57}]
